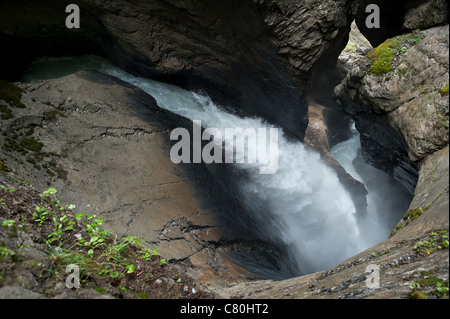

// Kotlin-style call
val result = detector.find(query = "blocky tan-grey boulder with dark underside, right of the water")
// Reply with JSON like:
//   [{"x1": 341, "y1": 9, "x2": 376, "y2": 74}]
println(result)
[{"x1": 335, "y1": 26, "x2": 448, "y2": 190}]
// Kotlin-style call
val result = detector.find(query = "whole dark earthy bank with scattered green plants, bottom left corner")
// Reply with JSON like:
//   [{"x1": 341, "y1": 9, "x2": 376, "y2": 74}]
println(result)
[{"x1": 0, "y1": 173, "x2": 213, "y2": 299}]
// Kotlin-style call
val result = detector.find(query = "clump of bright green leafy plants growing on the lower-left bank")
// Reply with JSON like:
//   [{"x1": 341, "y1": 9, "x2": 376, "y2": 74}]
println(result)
[{"x1": 28, "y1": 188, "x2": 169, "y2": 278}]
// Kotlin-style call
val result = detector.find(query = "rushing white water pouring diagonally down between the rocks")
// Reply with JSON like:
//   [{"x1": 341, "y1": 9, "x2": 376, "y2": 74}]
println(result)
[{"x1": 24, "y1": 56, "x2": 412, "y2": 273}]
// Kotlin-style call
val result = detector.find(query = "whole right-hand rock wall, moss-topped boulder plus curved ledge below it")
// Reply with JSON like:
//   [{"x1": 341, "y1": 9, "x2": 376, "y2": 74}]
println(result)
[{"x1": 213, "y1": 8, "x2": 449, "y2": 299}]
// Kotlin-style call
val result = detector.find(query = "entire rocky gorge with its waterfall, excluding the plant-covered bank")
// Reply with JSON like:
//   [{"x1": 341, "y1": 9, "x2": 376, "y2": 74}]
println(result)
[{"x1": 0, "y1": 0, "x2": 449, "y2": 299}]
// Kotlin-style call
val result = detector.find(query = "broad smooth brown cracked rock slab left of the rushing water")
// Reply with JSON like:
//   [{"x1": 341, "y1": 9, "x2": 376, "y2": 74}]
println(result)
[{"x1": 0, "y1": 71, "x2": 278, "y2": 284}]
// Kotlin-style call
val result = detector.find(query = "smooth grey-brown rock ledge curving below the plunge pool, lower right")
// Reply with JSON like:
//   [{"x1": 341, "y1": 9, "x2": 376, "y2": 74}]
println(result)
[{"x1": 216, "y1": 147, "x2": 449, "y2": 299}]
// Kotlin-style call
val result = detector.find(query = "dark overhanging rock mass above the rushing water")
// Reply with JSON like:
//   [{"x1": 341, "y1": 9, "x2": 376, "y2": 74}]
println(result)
[{"x1": 0, "y1": 0, "x2": 353, "y2": 139}]
